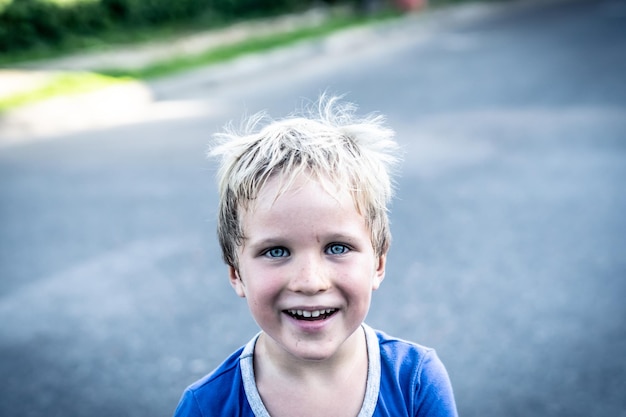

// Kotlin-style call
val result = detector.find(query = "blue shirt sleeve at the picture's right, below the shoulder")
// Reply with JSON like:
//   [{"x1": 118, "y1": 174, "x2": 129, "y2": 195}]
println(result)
[{"x1": 415, "y1": 350, "x2": 458, "y2": 417}]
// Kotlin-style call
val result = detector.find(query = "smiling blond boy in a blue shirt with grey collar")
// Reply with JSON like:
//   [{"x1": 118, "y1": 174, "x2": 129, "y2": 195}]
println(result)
[{"x1": 175, "y1": 98, "x2": 457, "y2": 417}]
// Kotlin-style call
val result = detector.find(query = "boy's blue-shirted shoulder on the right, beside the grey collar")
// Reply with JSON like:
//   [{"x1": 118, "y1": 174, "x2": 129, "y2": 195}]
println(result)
[{"x1": 368, "y1": 330, "x2": 457, "y2": 417}]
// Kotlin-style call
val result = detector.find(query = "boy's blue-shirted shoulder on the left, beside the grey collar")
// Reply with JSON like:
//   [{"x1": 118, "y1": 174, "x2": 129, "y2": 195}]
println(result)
[{"x1": 174, "y1": 348, "x2": 247, "y2": 417}]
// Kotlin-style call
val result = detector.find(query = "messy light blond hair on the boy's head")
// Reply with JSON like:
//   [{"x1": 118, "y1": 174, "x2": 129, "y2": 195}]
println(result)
[{"x1": 209, "y1": 96, "x2": 398, "y2": 268}]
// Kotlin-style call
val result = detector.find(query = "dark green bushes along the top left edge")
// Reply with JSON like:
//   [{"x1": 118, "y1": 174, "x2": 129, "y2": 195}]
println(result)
[{"x1": 0, "y1": 0, "x2": 314, "y2": 52}]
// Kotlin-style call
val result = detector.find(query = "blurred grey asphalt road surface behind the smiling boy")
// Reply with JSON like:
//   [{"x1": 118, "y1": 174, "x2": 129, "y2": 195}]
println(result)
[{"x1": 0, "y1": 0, "x2": 626, "y2": 417}]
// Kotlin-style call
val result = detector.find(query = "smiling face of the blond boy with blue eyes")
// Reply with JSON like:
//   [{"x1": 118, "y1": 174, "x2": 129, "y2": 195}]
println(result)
[{"x1": 230, "y1": 177, "x2": 385, "y2": 360}]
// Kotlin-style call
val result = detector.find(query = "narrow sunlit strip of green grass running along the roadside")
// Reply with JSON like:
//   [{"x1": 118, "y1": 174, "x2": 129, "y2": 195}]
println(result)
[{"x1": 0, "y1": 12, "x2": 399, "y2": 113}]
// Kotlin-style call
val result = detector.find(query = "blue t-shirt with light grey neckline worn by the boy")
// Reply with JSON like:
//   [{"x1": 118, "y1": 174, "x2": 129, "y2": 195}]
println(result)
[{"x1": 174, "y1": 324, "x2": 457, "y2": 417}]
